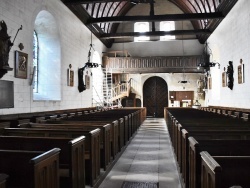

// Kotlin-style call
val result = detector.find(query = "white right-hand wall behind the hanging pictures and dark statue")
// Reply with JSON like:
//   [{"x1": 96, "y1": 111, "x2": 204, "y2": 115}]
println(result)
[{"x1": 206, "y1": 0, "x2": 250, "y2": 108}]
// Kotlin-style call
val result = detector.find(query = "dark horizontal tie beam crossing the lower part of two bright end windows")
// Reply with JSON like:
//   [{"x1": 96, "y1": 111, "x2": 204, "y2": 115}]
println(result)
[{"x1": 100, "y1": 29, "x2": 211, "y2": 39}]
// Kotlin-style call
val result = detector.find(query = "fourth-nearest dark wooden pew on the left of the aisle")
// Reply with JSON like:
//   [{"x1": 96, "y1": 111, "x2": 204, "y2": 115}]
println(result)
[{"x1": 19, "y1": 121, "x2": 111, "y2": 170}]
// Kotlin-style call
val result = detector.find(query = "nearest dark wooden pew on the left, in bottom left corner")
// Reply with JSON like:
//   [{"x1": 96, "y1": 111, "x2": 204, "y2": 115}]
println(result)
[{"x1": 0, "y1": 148, "x2": 60, "y2": 188}]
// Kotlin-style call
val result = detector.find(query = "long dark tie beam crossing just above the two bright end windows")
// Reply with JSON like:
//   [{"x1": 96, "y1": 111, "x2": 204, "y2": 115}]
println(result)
[{"x1": 87, "y1": 12, "x2": 224, "y2": 24}]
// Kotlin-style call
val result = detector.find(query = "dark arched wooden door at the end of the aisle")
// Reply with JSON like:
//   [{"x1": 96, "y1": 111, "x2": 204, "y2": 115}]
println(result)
[{"x1": 143, "y1": 76, "x2": 168, "y2": 117}]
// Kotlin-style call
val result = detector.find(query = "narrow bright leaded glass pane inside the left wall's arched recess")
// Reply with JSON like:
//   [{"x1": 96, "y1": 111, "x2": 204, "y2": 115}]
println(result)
[{"x1": 33, "y1": 31, "x2": 39, "y2": 93}]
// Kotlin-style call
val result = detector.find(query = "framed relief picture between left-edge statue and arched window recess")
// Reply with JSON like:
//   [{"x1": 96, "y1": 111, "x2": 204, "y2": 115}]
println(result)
[{"x1": 15, "y1": 51, "x2": 28, "y2": 79}]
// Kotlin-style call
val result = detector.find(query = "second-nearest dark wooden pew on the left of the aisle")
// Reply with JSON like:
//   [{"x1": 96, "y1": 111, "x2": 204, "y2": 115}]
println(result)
[{"x1": 0, "y1": 136, "x2": 85, "y2": 188}]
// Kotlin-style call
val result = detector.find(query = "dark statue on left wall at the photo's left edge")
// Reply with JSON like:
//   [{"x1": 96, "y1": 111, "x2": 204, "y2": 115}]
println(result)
[{"x1": 0, "y1": 20, "x2": 22, "y2": 78}]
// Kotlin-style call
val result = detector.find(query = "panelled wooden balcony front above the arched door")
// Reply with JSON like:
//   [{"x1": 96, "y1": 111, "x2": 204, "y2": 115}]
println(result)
[{"x1": 103, "y1": 56, "x2": 204, "y2": 73}]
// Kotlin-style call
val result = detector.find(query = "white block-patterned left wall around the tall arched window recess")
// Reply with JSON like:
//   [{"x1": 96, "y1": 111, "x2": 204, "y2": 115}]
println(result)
[{"x1": 0, "y1": 0, "x2": 105, "y2": 115}]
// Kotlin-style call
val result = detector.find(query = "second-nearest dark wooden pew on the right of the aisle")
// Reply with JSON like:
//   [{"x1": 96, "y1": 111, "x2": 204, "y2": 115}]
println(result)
[{"x1": 188, "y1": 137, "x2": 250, "y2": 188}]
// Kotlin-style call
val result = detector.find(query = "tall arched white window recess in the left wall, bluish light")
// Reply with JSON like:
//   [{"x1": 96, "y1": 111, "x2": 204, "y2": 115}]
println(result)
[{"x1": 33, "y1": 10, "x2": 61, "y2": 101}]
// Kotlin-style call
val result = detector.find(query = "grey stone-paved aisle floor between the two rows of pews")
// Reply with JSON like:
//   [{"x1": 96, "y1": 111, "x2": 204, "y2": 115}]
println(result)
[{"x1": 99, "y1": 118, "x2": 181, "y2": 188}]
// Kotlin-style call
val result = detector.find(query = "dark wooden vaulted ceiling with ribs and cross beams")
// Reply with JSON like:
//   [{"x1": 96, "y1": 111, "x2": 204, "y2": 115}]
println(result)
[{"x1": 62, "y1": 0, "x2": 238, "y2": 48}]
